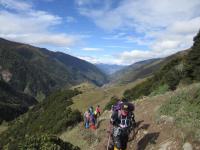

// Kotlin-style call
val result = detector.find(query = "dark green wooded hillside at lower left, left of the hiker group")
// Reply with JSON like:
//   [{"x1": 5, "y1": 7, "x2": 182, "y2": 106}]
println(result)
[{"x1": 0, "y1": 90, "x2": 82, "y2": 150}]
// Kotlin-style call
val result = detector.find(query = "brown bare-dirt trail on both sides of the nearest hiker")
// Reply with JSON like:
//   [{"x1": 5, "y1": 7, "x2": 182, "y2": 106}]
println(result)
[{"x1": 93, "y1": 93, "x2": 183, "y2": 150}]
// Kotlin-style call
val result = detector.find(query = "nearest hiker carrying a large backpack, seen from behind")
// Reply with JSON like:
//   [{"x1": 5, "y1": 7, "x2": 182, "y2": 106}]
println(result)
[{"x1": 109, "y1": 102, "x2": 135, "y2": 150}]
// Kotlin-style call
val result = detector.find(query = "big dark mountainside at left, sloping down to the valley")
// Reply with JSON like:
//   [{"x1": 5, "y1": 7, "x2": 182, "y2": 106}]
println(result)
[{"x1": 0, "y1": 39, "x2": 107, "y2": 99}]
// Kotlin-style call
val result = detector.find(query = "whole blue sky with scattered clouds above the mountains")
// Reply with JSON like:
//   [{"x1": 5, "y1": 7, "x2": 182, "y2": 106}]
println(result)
[{"x1": 0, "y1": 0, "x2": 200, "y2": 65}]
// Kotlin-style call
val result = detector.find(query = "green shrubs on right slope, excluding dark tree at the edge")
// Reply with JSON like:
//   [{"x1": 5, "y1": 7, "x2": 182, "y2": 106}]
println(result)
[{"x1": 124, "y1": 48, "x2": 188, "y2": 100}]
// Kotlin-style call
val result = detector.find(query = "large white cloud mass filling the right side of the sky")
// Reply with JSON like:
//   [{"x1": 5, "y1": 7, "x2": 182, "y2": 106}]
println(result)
[{"x1": 79, "y1": 0, "x2": 200, "y2": 63}]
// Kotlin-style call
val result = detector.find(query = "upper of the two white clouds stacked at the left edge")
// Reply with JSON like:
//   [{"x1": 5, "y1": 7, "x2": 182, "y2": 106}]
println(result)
[{"x1": 0, "y1": 11, "x2": 61, "y2": 34}]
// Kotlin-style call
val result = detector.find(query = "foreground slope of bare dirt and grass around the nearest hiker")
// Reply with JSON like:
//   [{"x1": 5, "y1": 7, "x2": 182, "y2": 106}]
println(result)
[{"x1": 95, "y1": 84, "x2": 200, "y2": 150}]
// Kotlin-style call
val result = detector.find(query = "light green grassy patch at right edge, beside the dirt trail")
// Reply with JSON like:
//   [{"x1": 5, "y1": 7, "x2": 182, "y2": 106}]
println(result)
[{"x1": 159, "y1": 84, "x2": 200, "y2": 139}]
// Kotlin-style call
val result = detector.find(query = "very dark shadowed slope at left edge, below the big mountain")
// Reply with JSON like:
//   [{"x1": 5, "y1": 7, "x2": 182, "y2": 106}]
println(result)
[{"x1": 0, "y1": 80, "x2": 37, "y2": 123}]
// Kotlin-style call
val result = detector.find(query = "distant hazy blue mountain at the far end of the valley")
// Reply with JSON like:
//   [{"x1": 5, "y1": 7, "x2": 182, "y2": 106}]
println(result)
[{"x1": 95, "y1": 64, "x2": 125, "y2": 75}]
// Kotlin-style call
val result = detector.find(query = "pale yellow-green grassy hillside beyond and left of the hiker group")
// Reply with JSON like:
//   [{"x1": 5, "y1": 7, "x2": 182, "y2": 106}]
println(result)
[{"x1": 60, "y1": 81, "x2": 141, "y2": 149}]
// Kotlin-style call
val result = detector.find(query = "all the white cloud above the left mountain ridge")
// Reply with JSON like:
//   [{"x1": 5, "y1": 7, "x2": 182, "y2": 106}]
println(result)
[{"x1": 0, "y1": 0, "x2": 83, "y2": 47}]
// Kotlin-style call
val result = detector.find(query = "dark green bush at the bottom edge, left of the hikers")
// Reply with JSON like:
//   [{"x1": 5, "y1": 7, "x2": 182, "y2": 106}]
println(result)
[{"x1": 18, "y1": 134, "x2": 80, "y2": 150}]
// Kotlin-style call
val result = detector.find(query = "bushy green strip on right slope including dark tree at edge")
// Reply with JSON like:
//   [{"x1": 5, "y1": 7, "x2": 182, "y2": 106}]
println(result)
[{"x1": 124, "y1": 31, "x2": 200, "y2": 100}]
